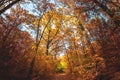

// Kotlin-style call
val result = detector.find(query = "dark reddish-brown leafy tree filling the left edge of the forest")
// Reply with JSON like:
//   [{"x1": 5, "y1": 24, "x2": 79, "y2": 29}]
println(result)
[{"x1": 0, "y1": 6, "x2": 34, "y2": 80}]
